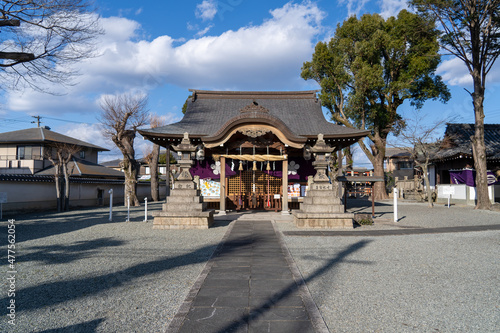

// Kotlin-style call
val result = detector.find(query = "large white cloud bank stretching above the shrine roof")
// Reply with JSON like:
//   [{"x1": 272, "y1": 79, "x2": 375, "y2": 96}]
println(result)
[{"x1": 2, "y1": 3, "x2": 325, "y2": 117}]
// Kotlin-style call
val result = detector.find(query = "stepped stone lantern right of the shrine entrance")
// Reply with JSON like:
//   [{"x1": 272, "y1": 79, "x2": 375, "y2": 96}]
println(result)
[{"x1": 292, "y1": 134, "x2": 354, "y2": 228}]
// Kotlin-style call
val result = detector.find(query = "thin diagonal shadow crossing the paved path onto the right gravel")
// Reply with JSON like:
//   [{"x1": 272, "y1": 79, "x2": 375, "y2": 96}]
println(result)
[{"x1": 217, "y1": 240, "x2": 371, "y2": 333}]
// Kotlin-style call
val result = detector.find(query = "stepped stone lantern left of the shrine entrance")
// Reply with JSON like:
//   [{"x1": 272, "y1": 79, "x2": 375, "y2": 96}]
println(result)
[{"x1": 153, "y1": 133, "x2": 214, "y2": 229}]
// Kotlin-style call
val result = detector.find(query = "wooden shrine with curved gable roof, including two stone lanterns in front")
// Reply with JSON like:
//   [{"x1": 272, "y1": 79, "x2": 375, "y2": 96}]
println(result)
[{"x1": 139, "y1": 90, "x2": 368, "y2": 229}]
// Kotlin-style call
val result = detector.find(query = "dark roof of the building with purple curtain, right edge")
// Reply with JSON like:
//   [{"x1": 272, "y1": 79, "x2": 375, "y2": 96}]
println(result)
[{"x1": 433, "y1": 123, "x2": 500, "y2": 160}]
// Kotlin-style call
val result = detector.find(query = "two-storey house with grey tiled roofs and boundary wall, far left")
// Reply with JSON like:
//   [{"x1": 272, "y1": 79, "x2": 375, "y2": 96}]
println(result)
[{"x1": 0, "y1": 127, "x2": 135, "y2": 211}]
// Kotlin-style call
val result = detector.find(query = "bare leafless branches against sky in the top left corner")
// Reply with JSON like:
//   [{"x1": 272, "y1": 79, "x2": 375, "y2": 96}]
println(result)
[{"x1": 0, "y1": 0, "x2": 102, "y2": 92}]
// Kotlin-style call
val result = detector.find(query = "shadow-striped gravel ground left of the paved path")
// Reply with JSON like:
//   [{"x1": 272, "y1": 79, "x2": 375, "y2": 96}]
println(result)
[{"x1": 0, "y1": 205, "x2": 228, "y2": 332}]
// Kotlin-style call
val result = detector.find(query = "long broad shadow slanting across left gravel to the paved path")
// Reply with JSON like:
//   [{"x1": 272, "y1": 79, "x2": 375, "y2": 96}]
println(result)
[{"x1": 0, "y1": 233, "x2": 248, "y2": 312}]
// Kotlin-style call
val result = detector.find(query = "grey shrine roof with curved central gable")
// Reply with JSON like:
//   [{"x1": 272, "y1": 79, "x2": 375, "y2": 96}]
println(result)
[{"x1": 139, "y1": 90, "x2": 368, "y2": 142}]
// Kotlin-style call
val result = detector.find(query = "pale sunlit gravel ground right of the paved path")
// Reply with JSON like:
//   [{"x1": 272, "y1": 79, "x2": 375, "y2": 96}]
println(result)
[{"x1": 276, "y1": 198, "x2": 500, "y2": 332}]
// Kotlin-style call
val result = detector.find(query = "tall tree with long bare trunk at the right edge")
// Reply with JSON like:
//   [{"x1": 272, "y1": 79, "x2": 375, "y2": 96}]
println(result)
[{"x1": 411, "y1": 0, "x2": 500, "y2": 209}]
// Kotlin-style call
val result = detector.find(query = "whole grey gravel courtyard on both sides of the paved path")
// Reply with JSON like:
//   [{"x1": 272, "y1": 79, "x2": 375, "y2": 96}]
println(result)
[{"x1": 0, "y1": 201, "x2": 500, "y2": 332}]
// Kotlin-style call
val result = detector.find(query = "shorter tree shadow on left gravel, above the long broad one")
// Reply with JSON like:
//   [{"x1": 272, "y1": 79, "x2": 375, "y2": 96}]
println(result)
[{"x1": 16, "y1": 237, "x2": 126, "y2": 265}]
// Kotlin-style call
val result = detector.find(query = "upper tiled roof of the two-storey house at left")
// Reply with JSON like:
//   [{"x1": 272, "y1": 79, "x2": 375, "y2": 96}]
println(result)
[{"x1": 0, "y1": 127, "x2": 109, "y2": 151}]
